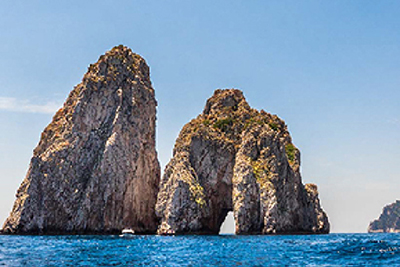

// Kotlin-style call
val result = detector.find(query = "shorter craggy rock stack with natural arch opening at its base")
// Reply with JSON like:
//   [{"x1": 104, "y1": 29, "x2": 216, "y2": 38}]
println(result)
[{"x1": 156, "y1": 89, "x2": 329, "y2": 234}]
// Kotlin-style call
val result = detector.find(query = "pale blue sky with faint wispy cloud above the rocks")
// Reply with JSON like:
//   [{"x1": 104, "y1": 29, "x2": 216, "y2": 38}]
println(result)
[{"x1": 0, "y1": 0, "x2": 400, "y2": 232}]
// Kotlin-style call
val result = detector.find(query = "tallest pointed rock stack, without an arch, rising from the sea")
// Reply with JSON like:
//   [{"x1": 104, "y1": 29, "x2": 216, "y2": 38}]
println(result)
[{"x1": 3, "y1": 46, "x2": 160, "y2": 234}]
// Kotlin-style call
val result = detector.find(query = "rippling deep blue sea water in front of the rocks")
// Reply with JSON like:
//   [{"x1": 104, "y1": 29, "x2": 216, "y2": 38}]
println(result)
[{"x1": 0, "y1": 234, "x2": 400, "y2": 266}]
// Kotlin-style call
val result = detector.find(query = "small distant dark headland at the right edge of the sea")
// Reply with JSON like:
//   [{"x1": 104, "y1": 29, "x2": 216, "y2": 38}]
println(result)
[{"x1": 368, "y1": 200, "x2": 400, "y2": 233}]
